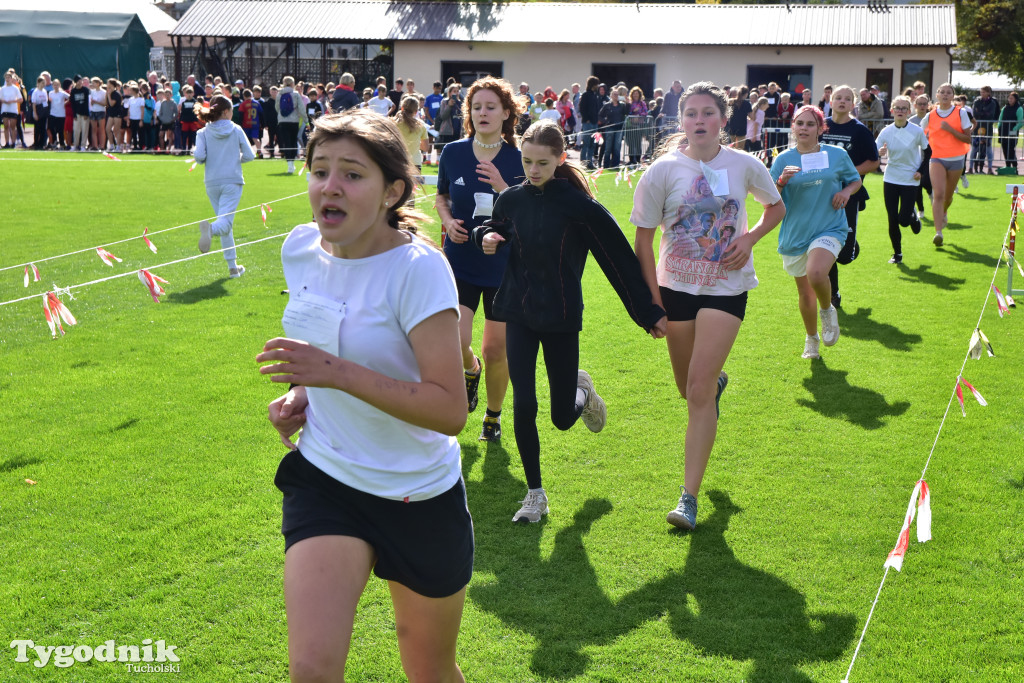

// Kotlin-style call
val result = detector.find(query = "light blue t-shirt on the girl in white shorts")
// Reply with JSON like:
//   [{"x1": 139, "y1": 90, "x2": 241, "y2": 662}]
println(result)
[{"x1": 771, "y1": 144, "x2": 860, "y2": 256}]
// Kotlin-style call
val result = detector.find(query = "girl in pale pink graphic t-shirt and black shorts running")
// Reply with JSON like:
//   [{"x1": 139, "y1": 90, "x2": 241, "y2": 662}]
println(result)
[{"x1": 630, "y1": 83, "x2": 785, "y2": 529}]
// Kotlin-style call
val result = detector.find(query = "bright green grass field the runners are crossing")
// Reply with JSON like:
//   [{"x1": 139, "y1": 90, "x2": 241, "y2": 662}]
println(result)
[{"x1": 0, "y1": 153, "x2": 1024, "y2": 682}]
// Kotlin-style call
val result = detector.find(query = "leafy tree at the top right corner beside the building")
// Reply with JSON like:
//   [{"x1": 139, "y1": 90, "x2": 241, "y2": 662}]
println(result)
[{"x1": 956, "y1": 0, "x2": 1024, "y2": 81}]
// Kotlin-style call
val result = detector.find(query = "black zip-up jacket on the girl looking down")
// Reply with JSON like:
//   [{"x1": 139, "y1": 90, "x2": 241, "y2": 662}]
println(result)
[{"x1": 472, "y1": 178, "x2": 665, "y2": 332}]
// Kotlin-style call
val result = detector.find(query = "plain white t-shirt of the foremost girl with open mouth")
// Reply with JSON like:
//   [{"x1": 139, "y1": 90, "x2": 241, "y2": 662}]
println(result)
[{"x1": 281, "y1": 223, "x2": 462, "y2": 501}]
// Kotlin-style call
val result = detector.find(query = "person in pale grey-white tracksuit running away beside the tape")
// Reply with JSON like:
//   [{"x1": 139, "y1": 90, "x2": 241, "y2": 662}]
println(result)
[{"x1": 195, "y1": 95, "x2": 256, "y2": 278}]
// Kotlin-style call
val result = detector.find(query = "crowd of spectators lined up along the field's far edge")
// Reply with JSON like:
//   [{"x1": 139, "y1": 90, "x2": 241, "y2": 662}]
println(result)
[{"x1": 2, "y1": 69, "x2": 1024, "y2": 173}]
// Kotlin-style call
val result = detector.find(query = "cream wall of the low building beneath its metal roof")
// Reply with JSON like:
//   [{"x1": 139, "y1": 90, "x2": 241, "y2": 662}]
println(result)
[{"x1": 394, "y1": 41, "x2": 950, "y2": 95}]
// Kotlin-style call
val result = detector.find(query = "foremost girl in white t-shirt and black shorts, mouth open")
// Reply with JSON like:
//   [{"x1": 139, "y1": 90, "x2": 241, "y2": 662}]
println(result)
[{"x1": 257, "y1": 110, "x2": 473, "y2": 681}]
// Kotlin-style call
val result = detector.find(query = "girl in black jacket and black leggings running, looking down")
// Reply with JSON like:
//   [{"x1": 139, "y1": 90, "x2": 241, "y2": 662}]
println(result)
[{"x1": 473, "y1": 121, "x2": 667, "y2": 522}]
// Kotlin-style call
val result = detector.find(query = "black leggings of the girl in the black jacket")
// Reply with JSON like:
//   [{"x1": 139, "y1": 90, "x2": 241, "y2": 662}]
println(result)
[{"x1": 505, "y1": 323, "x2": 583, "y2": 488}]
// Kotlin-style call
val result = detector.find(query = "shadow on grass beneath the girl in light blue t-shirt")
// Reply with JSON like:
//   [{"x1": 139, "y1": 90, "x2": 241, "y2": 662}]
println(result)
[{"x1": 797, "y1": 360, "x2": 910, "y2": 429}]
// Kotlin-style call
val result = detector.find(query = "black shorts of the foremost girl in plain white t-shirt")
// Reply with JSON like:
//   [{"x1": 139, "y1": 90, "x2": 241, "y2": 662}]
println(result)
[{"x1": 273, "y1": 451, "x2": 473, "y2": 598}]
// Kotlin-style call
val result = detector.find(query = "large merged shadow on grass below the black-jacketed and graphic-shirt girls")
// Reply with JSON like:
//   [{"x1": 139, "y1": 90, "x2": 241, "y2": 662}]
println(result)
[{"x1": 463, "y1": 444, "x2": 856, "y2": 682}]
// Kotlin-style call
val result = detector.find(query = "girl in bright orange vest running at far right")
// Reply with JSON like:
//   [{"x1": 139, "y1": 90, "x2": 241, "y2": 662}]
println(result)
[{"x1": 921, "y1": 83, "x2": 972, "y2": 247}]
